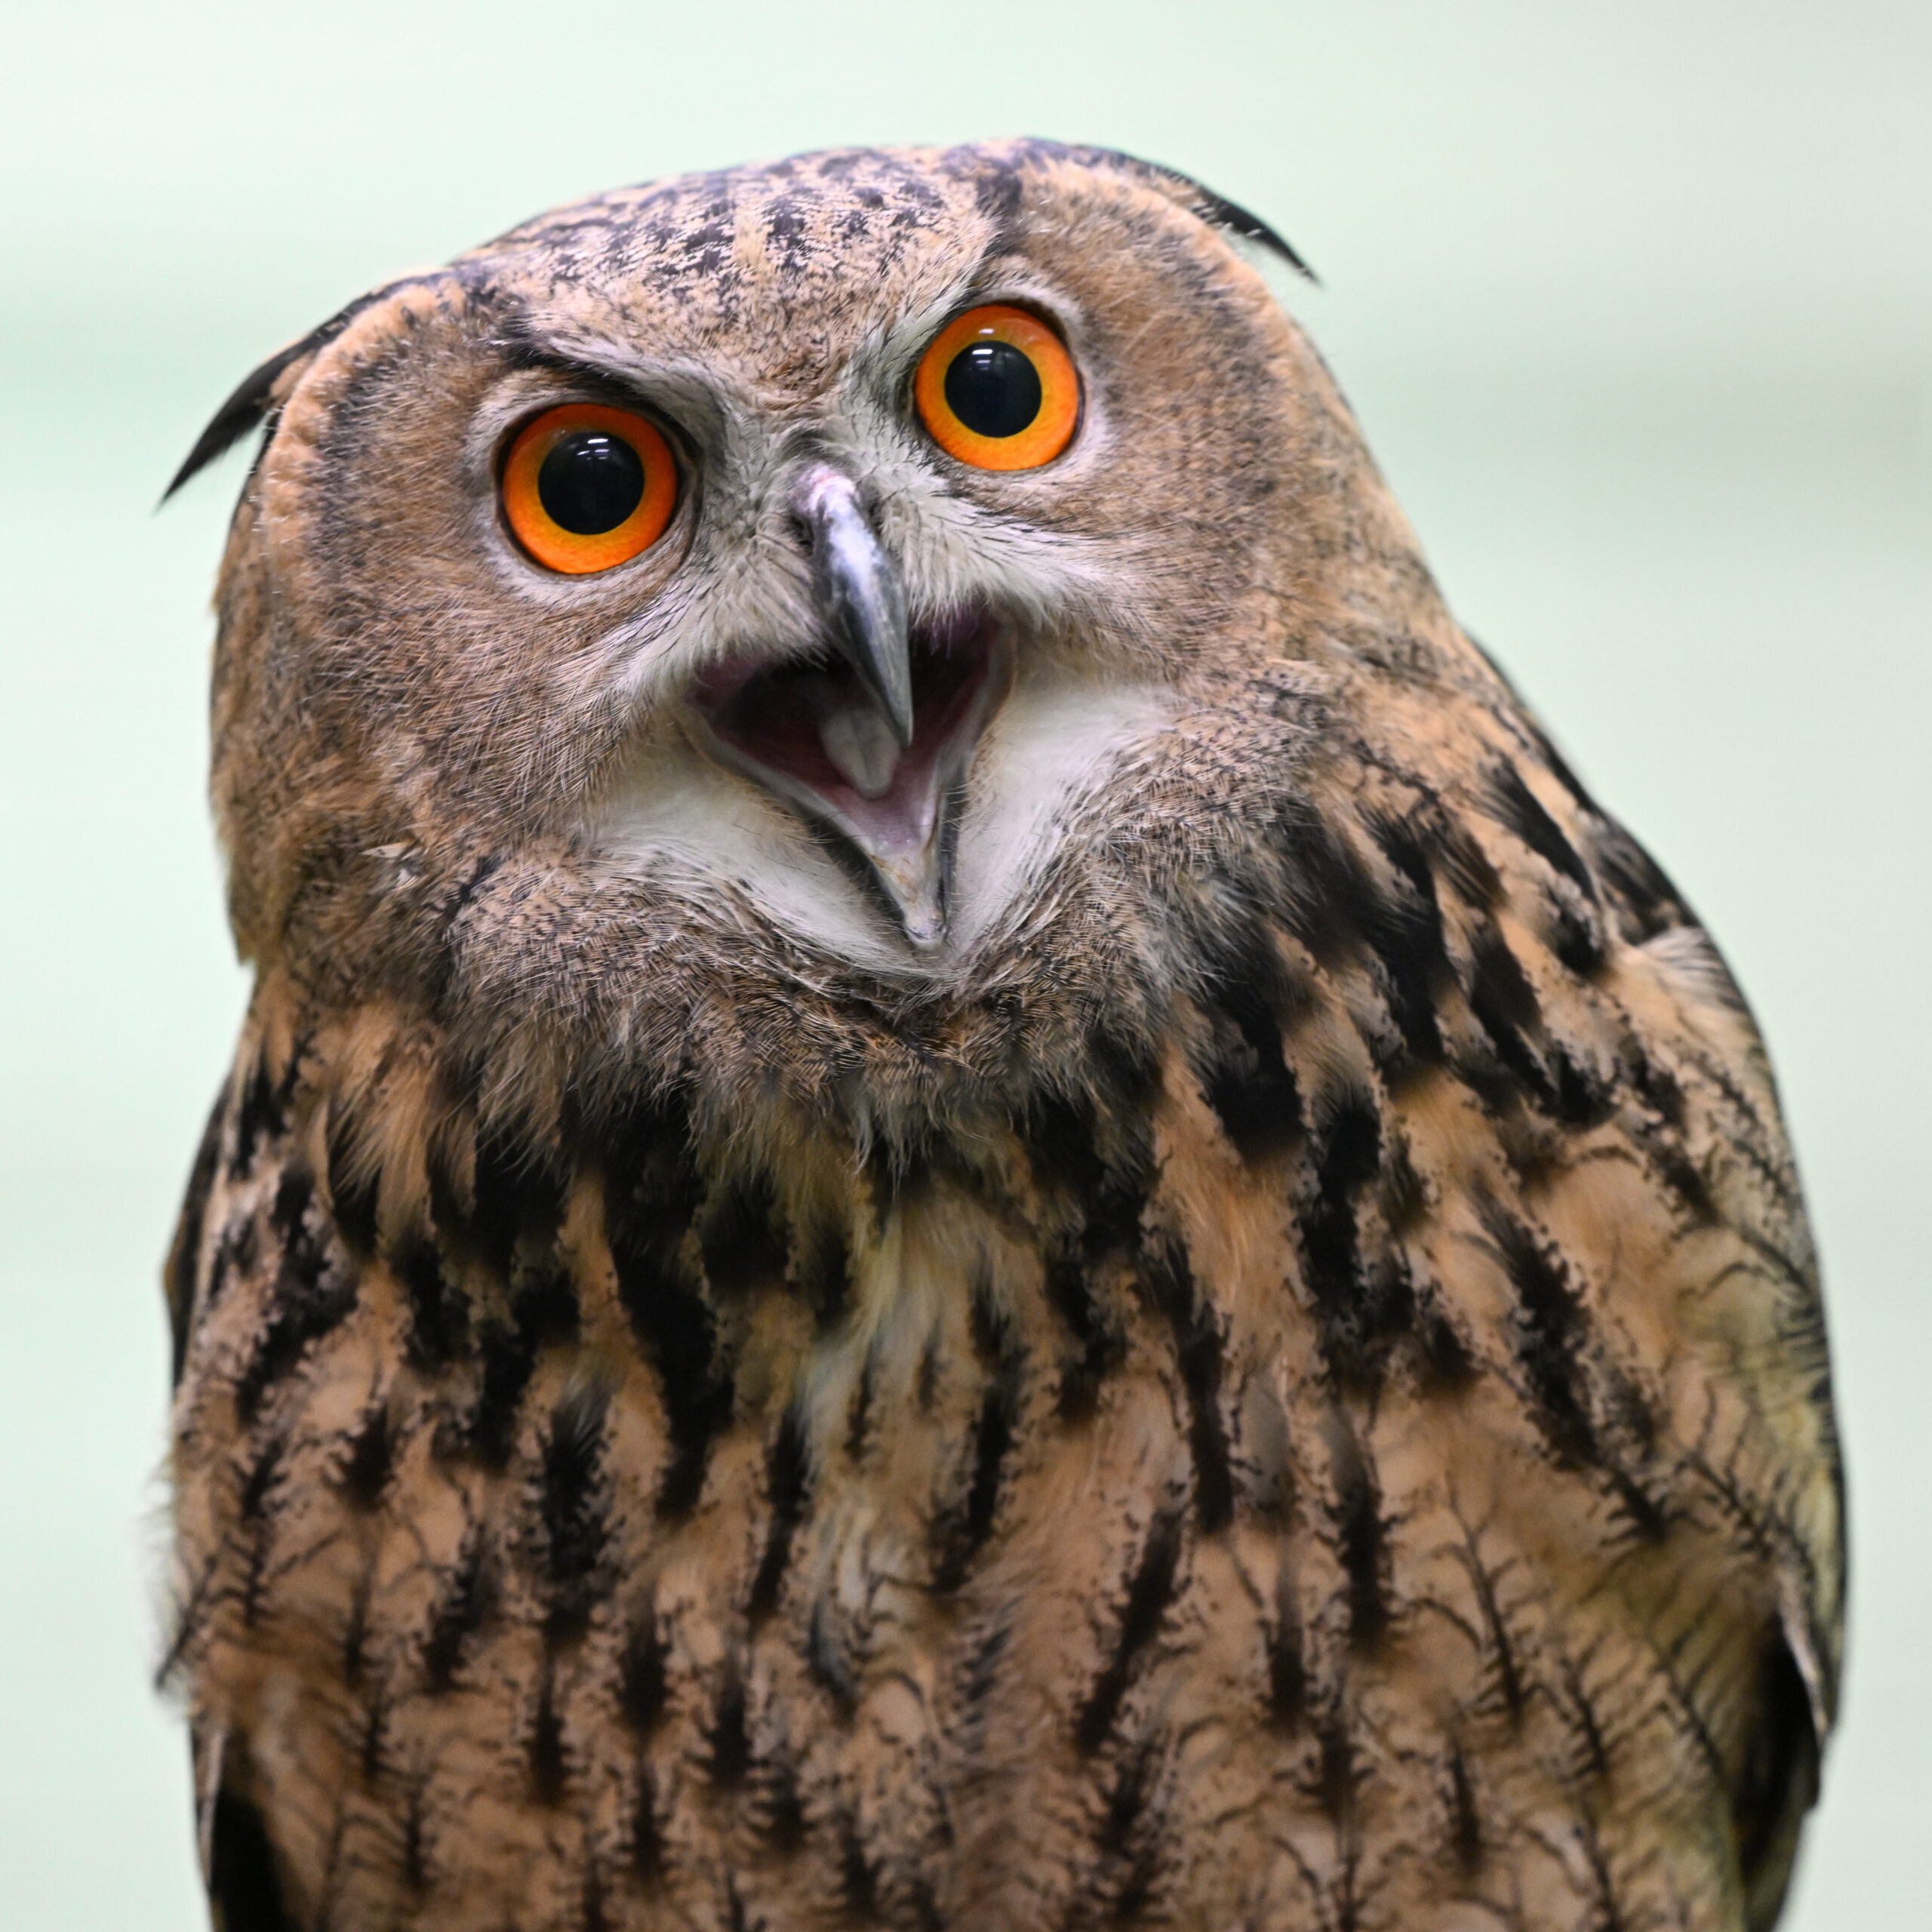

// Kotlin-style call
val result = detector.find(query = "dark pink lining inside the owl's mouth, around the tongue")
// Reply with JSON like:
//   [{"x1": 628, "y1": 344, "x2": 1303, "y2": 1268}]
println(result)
[{"x1": 691, "y1": 611, "x2": 993, "y2": 848}]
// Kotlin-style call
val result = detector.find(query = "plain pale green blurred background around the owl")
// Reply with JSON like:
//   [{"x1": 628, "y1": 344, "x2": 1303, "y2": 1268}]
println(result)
[{"x1": 0, "y1": 0, "x2": 1932, "y2": 1932}]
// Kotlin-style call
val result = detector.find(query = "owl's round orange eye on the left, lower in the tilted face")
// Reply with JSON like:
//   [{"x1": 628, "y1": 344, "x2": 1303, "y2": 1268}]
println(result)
[{"x1": 503, "y1": 401, "x2": 678, "y2": 576}]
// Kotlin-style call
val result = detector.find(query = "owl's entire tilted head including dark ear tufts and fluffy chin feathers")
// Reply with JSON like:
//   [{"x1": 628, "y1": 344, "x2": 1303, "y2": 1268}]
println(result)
[{"x1": 176, "y1": 141, "x2": 1487, "y2": 1136}]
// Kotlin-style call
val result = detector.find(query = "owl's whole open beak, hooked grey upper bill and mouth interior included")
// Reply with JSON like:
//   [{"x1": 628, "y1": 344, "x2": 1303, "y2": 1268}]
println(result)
[{"x1": 691, "y1": 463, "x2": 1008, "y2": 946}]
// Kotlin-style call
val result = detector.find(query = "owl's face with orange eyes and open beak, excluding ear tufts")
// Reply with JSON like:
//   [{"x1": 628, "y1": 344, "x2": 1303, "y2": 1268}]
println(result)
[{"x1": 204, "y1": 145, "x2": 1337, "y2": 974}]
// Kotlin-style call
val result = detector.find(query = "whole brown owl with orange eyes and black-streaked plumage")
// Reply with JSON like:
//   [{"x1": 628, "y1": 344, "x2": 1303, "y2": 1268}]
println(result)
[{"x1": 165, "y1": 141, "x2": 1843, "y2": 1932}]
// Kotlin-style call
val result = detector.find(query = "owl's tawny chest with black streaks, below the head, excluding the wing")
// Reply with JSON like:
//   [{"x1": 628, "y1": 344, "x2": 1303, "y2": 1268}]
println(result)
[{"x1": 176, "y1": 1074, "x2": 1769, "y2": 1932}]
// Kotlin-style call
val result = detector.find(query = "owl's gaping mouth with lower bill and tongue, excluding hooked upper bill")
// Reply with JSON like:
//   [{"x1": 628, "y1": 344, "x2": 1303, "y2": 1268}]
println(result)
[{"x1": 690, "y1": 607, "x2": 1011, "y2": 946}]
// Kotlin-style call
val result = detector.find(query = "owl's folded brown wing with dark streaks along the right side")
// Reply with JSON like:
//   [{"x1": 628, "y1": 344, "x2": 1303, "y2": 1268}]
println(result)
[{"x1": 1283, "y1": 666, "x2": 1845, "y2": 1928}]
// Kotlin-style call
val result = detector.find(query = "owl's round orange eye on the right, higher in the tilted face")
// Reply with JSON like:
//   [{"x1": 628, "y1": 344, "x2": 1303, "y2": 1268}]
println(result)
[{"x1": 912, "y1": 303, "x2": 1080, "y2": 469}]
